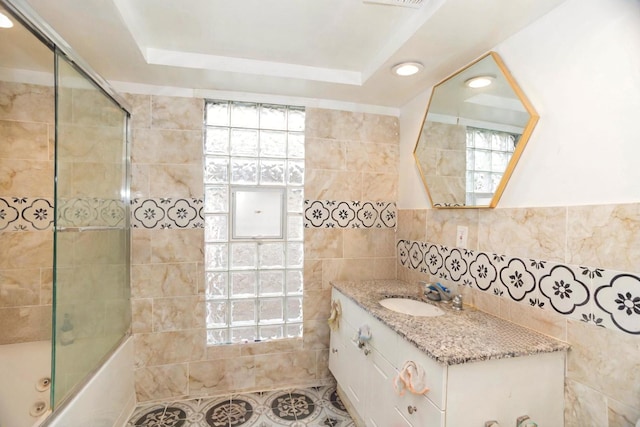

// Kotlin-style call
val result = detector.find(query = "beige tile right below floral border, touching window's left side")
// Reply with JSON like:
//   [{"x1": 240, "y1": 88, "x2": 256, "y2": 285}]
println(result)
[{"x1": 151, "y1": 229, "x2": 204, "y2": 263}]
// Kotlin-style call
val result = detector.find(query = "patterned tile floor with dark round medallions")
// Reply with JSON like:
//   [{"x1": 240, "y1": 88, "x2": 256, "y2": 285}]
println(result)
[{"x1": 127, "y1": 385, "x2": 355, "y2": 427}]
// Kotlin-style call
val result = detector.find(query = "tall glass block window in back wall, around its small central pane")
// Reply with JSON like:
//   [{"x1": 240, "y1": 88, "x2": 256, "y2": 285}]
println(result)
[{"x1": 203, "y1": 100, "x2": 305, "y2": 345}]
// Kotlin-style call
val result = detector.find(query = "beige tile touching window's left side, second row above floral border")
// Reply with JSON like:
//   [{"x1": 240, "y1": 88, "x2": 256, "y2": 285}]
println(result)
[{"x1": 131, "y1": 129, "x2": 202, "y2": 167}]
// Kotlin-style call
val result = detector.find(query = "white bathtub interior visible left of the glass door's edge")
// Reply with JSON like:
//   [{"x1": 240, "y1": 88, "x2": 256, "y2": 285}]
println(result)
[{"x1": 0, "y1": 341, "x2": 51, "y2": 427}]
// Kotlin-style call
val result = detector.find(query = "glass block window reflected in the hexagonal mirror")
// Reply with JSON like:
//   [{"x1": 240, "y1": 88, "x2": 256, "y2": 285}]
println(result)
[{"x1": 466, "y1": 126, "x2": 520, "y2": 206}]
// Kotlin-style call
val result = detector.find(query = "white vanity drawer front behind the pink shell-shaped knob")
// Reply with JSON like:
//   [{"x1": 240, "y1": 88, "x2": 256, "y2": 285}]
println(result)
[{"x1": 396, "y1": 338, "x2": 447, "y2": 410}]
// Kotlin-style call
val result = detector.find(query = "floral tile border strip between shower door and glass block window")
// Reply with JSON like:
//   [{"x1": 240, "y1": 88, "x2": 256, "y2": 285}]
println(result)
[{"x1": 131, "y1": 198, "x2": 204, "y2": 230}]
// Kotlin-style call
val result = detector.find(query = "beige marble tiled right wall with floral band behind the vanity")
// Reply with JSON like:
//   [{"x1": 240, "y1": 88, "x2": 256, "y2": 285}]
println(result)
[{"x1": 398, "y1": 204, "x2": 640, "y2": 427}]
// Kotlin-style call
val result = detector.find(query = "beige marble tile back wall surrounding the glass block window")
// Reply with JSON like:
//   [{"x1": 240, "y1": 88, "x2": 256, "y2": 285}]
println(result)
[{"x1": 127, "y1": 95, "x2": 398, "y2": 401}]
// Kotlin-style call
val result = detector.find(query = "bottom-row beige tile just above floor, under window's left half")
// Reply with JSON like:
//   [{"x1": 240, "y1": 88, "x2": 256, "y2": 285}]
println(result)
[{"x1": 189, "y1": 356, "x2": 256, "y2": 396}]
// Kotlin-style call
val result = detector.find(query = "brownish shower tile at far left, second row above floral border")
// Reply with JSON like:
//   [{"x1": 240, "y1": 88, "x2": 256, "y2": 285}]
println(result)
[{"x1": 0, "y1": 120, "x2": 50, "y2": 161}]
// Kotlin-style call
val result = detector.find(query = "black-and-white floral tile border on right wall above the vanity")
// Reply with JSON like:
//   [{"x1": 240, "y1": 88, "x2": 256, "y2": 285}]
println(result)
[{"x1": 396, "y1": 240, "x2": 640, "y2": 335}]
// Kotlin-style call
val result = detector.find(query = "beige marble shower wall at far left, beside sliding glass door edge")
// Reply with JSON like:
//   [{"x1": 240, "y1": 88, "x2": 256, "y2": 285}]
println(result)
[{"x1": 0, "y1": 82, "x2": 54, "y2": 345}]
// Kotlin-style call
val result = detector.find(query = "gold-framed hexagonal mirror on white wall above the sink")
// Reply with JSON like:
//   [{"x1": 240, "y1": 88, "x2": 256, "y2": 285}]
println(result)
[{"x1": 413, "y1": 52, "x2": 538, "y2": 208}]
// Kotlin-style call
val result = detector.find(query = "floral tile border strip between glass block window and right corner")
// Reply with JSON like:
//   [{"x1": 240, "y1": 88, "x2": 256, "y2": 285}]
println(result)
[{"x1": 304, "y1": 200, "x2": 398, "y2": 228}]
